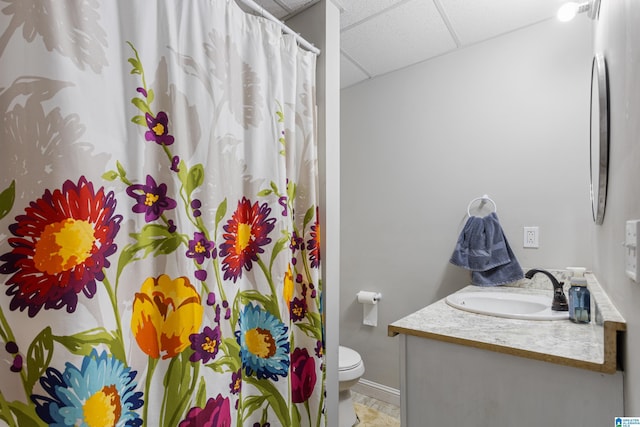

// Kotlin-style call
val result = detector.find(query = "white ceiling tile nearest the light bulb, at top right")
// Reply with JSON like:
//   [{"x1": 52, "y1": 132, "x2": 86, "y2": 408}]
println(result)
[{"x1": 434, "y1": 0, "x2": 564, "y2": 45}]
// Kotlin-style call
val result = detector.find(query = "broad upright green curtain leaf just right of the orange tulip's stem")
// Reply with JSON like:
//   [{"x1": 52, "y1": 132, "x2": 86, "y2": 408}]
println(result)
[{"x1": 161, "y1": 351, "x2": 195, "y2": 426}]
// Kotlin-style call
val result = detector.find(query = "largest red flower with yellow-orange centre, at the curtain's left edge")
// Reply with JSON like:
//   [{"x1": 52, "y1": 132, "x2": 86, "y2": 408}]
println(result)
[{"x1": 0, "y1": 176, "x2": 122, "y2": 317}]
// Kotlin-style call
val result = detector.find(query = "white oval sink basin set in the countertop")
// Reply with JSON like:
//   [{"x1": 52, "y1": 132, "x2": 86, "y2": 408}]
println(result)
[{"x1": 445, "y1": 290, "x2": 569, "y2": 320}]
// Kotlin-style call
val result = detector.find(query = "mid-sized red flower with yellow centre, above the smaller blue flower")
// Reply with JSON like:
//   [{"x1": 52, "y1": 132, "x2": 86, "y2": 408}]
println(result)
[{"x1": 220, "y1": 197, "x2": 276, "y2": 283}]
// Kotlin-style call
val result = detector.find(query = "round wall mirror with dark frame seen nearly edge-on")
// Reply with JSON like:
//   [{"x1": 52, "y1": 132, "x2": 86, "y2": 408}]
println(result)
[{"x1": 589, "y1": 54, "x2": 609, "y2": 225}]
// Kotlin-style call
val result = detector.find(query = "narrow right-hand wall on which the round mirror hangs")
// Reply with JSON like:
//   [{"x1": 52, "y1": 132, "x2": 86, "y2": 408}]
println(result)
[{"x1": 594, "y1": 0, "x2": 640, "y2": 416}]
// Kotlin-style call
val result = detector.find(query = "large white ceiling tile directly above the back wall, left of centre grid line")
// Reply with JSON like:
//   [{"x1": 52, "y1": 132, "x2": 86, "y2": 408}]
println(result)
[{"x1": 341, "y1": 0, "x2": 456, "y2": 75}]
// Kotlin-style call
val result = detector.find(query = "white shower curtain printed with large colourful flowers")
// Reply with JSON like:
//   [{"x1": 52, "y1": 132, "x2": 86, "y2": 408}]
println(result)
[{"x1": 0, "y1": 0, "x2": 325, "y2": 427}]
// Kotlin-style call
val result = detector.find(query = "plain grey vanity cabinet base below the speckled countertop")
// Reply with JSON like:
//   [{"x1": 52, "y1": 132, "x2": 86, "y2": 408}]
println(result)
[{"x1": 399, "y1": 335, "x2": 624, "y2": 427}]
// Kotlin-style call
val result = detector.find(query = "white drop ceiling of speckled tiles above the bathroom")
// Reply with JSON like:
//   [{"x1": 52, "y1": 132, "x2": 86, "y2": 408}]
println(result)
[{"x1": 250, "y1": 0, "x2": 565, "y2": 88}]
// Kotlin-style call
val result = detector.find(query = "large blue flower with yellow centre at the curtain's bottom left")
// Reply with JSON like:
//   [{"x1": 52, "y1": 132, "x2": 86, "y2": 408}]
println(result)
[{"x1": 31, "y1": 349, "x2": 143, "y2": 426}]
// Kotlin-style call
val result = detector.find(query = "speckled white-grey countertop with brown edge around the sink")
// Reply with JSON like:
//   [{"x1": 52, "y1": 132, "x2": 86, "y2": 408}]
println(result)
[{"x1": 388, "y1": 272, "x2": 626, "y2": 373}]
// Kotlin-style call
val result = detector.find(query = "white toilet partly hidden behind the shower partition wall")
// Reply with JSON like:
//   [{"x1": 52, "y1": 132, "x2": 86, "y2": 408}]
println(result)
[{"x1": 338, "y1": 346, "x2": 364, "y2": 427}]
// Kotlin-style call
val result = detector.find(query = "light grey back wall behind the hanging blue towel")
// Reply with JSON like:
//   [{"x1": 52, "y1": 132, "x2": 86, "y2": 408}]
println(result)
[{"x1": 340, "y1": 15, "x2": 592, "y2": 388}]
